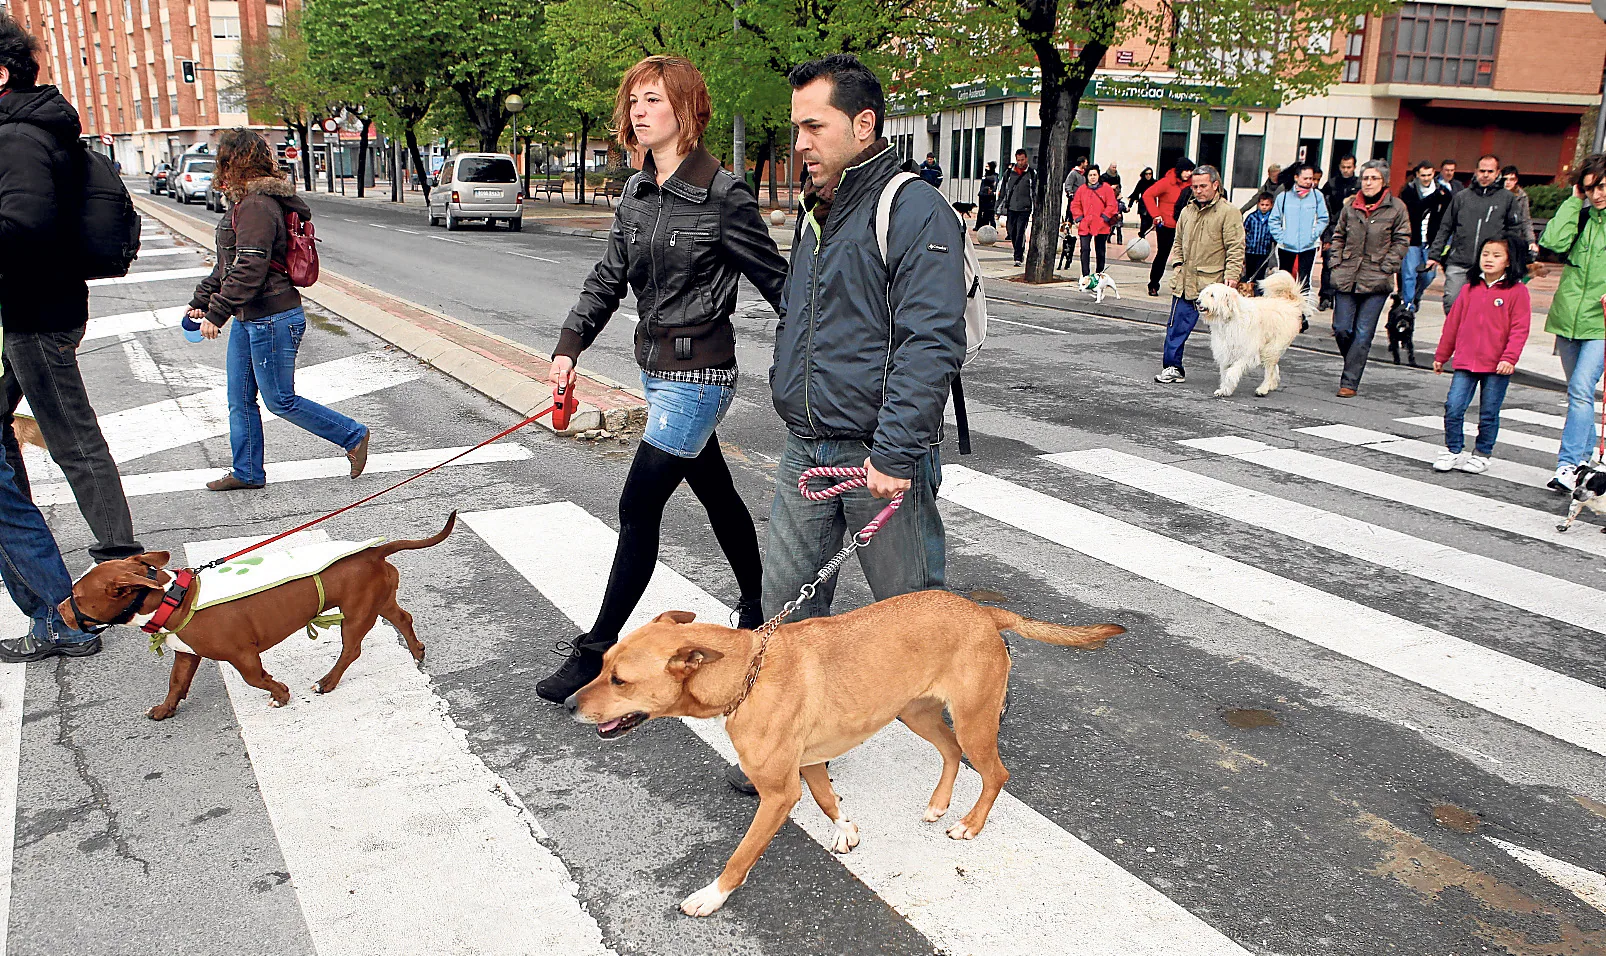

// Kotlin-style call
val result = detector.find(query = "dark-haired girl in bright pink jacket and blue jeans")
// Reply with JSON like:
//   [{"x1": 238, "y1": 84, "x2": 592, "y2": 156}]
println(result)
[{"x1": 1433, "y1": 238, "x2": 1531, "y2": 474}]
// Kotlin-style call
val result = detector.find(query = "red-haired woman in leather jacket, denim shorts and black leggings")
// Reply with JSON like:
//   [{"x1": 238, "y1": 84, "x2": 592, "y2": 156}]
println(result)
[{"x1": 536, "y1": 56, "x2": 787, "y2": 702}]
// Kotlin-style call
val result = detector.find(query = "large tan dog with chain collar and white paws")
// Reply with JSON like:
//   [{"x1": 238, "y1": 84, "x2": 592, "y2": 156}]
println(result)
[{"x1": 567, "y1": 591, "x2": 1126, "y2": 916}]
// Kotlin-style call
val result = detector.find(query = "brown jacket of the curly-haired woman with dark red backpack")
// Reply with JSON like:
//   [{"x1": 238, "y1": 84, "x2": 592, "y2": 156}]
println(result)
[{"x1": 190, "y1": 177, "x2": 312, "y2": 326}]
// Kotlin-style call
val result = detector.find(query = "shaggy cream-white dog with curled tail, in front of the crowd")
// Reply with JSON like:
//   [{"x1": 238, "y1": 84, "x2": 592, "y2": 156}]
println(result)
[{"x1": 1200, "y1": 272, "x2": 1315, "y2": 398}]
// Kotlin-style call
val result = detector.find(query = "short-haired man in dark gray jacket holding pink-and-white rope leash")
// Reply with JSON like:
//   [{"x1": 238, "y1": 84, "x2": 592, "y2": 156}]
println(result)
[{"x1": 763, "y1": 53, "x2": 965, "y2": 620}]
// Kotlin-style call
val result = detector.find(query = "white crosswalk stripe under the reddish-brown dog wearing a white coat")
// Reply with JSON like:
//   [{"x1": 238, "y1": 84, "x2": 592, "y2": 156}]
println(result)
[{"x1": 185, "y1": 532, "x2": 612, "y2": 956}]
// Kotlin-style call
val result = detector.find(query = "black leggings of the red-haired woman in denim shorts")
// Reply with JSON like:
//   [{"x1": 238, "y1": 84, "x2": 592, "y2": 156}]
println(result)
[{"x1": 588, "y1": 434, "x2": 764, "y2": 644}]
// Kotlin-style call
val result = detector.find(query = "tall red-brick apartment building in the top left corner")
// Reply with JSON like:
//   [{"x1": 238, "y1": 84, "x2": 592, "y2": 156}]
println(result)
[{"x1": 6, "y1": 0, "x2": 296, "y2": 172}]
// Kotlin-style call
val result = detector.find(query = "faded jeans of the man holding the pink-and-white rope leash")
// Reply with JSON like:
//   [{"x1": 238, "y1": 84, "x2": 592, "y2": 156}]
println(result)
[{"x1": 764, "y1": 432, "x2": 946, "y2": 620}]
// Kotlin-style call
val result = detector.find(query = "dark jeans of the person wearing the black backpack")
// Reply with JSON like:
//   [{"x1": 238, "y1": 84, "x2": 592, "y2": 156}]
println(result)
[{"x1": 0, "y1": 326, "x2": 145, "y2": 561}]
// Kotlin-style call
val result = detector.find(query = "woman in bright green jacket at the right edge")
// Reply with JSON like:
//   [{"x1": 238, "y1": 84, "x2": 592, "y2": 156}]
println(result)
[{"x1": 1539, "y1": 153, "x2": 1606, "y2": 493}]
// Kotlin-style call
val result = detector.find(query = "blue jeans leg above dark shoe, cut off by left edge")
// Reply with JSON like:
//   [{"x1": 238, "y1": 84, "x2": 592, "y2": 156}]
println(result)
[{"x1": 0, "y1": 437, "x2": 93, "y2": 644}]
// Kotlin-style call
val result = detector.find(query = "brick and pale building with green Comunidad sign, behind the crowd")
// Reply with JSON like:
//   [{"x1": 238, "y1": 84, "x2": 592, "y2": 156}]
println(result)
[{"x1": 888, "y1": 0, "x2": 1606, "y2": 202}]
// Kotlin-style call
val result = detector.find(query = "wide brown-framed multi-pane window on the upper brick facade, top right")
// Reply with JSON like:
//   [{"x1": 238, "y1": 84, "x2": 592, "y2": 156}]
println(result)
[{"x1": 1378, "y1": 3, "x2": 1502, "y2": 87}]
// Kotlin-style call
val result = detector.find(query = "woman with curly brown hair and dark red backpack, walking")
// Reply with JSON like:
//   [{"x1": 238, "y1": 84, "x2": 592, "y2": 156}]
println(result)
[{"x1": 190, "y1": 129, "x2": 368, "y2": 492}]
